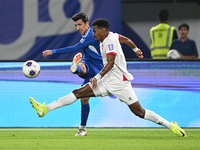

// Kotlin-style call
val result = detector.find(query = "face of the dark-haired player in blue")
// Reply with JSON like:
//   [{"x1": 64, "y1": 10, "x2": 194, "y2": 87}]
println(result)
[{"x1": 74, "y1": 19, "x2": 89, "y2": 34}]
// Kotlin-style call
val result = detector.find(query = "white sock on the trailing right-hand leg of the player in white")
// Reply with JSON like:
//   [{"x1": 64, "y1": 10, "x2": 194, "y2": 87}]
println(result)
[{"x1": 144, "y1": 109, "x2": 171, "y2": 129}]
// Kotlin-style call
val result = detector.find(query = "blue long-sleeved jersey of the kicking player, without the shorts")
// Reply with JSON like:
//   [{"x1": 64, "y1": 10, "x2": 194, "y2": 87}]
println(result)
[{"x1": 52, "y1": 27, "x2": 102, "y2": 61}]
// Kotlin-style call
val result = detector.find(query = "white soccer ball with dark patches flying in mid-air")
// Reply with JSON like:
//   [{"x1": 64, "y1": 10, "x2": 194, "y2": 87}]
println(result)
[{"x1": 22, "y1": 60, "x2": 40, "y2": 78}]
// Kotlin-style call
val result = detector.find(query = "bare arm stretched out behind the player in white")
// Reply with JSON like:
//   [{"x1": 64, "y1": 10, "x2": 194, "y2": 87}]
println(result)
[{"x1": 119, "y1": 35, "x2": 144, "y2": 58}]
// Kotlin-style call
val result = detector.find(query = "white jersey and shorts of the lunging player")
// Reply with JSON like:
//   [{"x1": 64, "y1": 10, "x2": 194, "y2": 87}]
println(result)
[{"x1": 89, "y1": 32, "x2": 138, "y2": 105}]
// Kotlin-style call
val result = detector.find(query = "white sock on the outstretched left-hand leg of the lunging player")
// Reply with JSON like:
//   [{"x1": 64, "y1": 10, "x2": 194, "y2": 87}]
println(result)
[{"x1": 46, "y1": 93, "x2": 77, "y2": 111}]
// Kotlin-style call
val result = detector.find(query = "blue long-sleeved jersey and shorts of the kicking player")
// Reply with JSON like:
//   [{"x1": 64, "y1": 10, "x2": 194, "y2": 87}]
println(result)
[{"x1": 52, "y1": 27, "x2": 103, "y2": 85}]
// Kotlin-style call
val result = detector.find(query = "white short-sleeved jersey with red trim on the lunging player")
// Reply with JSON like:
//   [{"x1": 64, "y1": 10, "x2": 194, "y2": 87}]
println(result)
[{"x1": 100, "y1": 32, "x2": 133, "y2": 82}]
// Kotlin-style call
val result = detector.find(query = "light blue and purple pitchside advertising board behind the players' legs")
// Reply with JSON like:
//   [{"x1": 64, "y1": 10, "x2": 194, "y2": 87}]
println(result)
[{"x1": 0, "y1": 61, "x2": 200, "y2": 127}]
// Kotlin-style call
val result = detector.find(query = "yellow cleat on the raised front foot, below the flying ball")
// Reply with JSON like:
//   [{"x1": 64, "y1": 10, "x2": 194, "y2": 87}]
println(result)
[{"x1": 29, "y1": 97, "x2": 48, "y2": 117}]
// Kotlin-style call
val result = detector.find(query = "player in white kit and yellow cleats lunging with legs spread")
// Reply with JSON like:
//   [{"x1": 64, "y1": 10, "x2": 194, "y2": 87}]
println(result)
[{"x1": 29, "y1": 19, "x2": 187, "y2": 137}]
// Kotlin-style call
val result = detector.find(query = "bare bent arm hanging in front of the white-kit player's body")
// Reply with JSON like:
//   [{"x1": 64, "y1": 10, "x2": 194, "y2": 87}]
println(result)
[{"x1": 90, "y1": 54, "x2": 116, "y2": 89}]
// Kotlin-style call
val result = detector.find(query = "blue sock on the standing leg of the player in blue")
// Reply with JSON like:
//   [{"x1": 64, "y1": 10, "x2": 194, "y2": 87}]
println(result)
[{"x1": 81, "y1": 104, "x2": 90, "y2": 126}]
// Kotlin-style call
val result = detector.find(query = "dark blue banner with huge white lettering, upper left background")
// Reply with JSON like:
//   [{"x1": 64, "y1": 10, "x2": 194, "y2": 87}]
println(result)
[{"x1": 0, "y1": 0, "x2": 121, "y2": 60}]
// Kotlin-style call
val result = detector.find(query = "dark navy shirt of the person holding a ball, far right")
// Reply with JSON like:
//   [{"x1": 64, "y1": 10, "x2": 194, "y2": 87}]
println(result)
[{"x1": 170, "y1": 38, "x2": 198, "y2": 56}]
